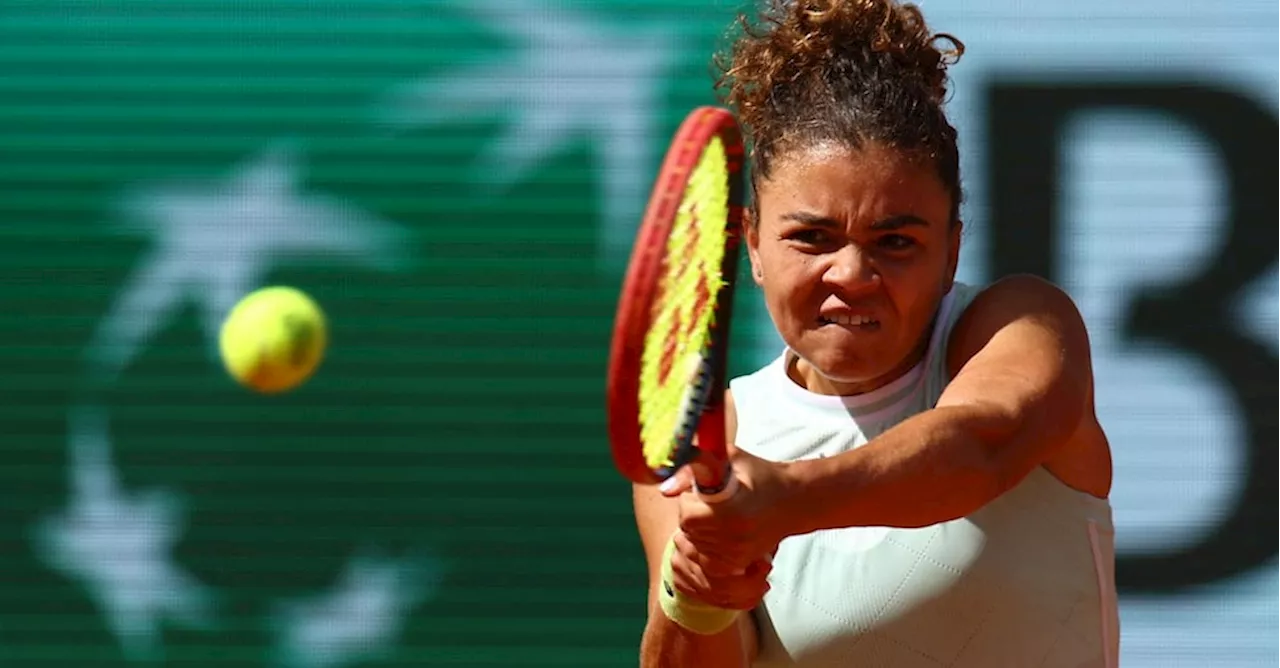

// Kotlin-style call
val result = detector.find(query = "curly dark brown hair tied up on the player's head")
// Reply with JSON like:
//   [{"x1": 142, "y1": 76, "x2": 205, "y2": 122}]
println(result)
[{"x1": 714, "y1": 0, "x2": 964, "y2": 223}]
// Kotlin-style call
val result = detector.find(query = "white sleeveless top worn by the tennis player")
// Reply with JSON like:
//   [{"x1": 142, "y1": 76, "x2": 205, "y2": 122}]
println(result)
[{"x1": 730, "y1": 283, "x2": 1119, "y2": 668}]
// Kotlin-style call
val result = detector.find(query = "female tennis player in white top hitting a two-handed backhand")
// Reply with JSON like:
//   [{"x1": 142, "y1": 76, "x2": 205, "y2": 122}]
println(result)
[{"x1": 635, "y1": 0, "x2": 1119, "y2": 668}]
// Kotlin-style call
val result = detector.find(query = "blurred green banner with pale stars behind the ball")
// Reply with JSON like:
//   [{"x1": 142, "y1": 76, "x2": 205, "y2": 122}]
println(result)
[{"x1": 0, "y1": 0, "x2": 757, "y2": 665}]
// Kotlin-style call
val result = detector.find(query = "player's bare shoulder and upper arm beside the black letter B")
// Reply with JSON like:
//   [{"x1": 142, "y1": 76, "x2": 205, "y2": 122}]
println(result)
[{"x1": 938, "y1": 275, "x2": 1093, "y2": 473}]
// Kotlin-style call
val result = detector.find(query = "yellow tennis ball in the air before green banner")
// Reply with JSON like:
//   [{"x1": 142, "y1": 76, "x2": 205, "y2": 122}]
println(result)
[{"x1": 218, "y1": 285, "x2": 328, "y2": 394}]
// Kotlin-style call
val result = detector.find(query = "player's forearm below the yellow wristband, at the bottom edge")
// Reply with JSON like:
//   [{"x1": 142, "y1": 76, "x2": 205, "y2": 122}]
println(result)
[{"x1": 640, "y1": 605, "x2": 754, "y2": 668}]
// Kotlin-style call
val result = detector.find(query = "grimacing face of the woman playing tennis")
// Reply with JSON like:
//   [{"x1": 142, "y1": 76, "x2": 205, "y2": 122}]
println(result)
[{"x1": 746, "y1": 138, "x2": 960, "y2": 394}]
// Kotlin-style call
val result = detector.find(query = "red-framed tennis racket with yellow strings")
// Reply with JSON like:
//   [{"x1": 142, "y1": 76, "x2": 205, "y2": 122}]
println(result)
[{"x1": 607, "y1": 106, "x2": 745, "y2": 495}]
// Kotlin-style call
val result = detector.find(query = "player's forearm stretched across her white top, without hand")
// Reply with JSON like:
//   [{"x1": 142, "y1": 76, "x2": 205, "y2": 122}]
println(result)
[{"x1": 790, "y1": 406, "x2": 1027, "y2": 534}]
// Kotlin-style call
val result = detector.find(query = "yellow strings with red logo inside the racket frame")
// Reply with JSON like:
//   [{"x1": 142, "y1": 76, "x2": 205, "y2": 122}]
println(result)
[{"x1": 639, "y1": 138, "x2": 730, "y2": 468}]
